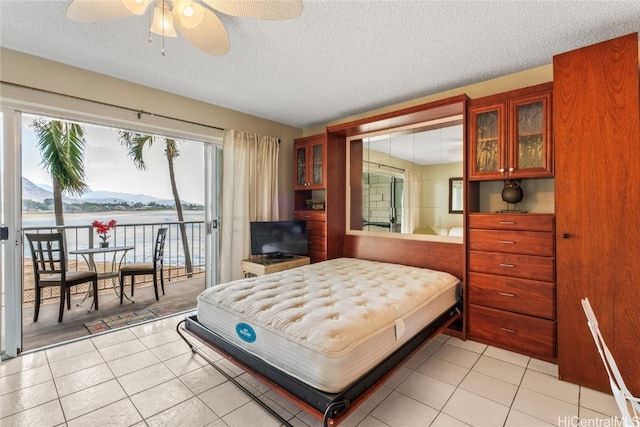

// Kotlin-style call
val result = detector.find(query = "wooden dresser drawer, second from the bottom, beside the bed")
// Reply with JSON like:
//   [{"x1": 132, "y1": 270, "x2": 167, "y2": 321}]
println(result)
[{"x1": 467, "y1": 273, "x2": 556, "y2": 319}]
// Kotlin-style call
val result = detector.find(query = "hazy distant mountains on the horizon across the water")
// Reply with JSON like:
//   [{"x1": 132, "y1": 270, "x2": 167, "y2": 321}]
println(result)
[{"x1": 22, "y1": 177, "x2": 189, "y2": 205}]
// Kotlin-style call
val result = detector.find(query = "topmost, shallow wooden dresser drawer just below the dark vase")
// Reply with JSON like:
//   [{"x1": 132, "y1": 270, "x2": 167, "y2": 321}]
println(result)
[{"x1": 468, "y1": 214, "x2": 555, "y2": 232}]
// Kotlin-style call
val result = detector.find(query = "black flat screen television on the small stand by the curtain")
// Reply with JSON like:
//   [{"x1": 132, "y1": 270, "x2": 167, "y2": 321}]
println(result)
[{"x1": 250, "y1": 221, "x2": 307, "y2": 258}]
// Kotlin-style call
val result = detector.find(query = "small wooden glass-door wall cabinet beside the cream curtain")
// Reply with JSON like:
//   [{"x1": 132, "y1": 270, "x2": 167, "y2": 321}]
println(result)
[{"x1": 293, "y1": 134, "x2": 326, "y2": 190}]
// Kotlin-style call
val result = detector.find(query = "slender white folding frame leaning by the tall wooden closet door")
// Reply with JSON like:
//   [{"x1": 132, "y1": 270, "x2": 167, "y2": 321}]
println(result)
[{"x1": 582, "y1": 298, "x2": 640, "y2": 427}]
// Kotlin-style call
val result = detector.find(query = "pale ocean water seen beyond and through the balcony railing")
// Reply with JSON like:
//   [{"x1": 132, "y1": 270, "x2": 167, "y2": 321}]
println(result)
[{"x1": 22, "y1": 210, "x2": 205, "y2": 266}]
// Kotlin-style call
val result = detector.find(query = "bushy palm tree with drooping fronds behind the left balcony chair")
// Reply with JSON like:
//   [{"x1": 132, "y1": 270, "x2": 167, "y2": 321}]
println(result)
[{"x1": 31, "y1": 119, "x2": 89, "y2": 226}]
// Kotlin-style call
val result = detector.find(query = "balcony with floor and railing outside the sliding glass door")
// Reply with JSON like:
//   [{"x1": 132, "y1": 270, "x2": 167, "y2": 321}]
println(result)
[{"x1": 22, "y1": 221, "x2": 205, "y2": 351}]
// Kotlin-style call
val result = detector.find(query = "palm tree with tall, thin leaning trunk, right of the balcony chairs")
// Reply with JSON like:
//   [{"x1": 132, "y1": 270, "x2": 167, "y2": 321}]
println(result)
[{"x1": 118, "y1": 131, "x2": 193, "y2": 277}]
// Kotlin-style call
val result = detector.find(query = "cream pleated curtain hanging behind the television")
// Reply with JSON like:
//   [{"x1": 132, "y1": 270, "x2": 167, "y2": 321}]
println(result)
[{"x1": 219, "y1": 129, "x2": 280, "y2": 283}]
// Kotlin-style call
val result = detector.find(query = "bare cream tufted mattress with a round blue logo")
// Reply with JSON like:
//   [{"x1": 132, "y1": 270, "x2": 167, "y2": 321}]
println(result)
[{"x1": 197, "y1": 258, "x2": 459, "y2": 393}]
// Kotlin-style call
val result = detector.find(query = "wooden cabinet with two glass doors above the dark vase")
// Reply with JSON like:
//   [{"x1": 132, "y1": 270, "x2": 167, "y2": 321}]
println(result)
[{"x1": 468, "y1": 83, "x2": 553, "y2": 180}]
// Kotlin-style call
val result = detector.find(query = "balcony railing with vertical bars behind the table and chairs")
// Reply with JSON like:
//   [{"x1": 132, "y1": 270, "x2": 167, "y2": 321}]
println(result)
[{"x1": 22, "y1": 221, "x2": 205, "y2": 307}]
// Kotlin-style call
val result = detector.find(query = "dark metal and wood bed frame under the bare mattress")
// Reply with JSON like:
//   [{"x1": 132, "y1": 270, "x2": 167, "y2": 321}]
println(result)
[{"x1": 176, "y1": 302, "x2": 461, "y2": 426}]
